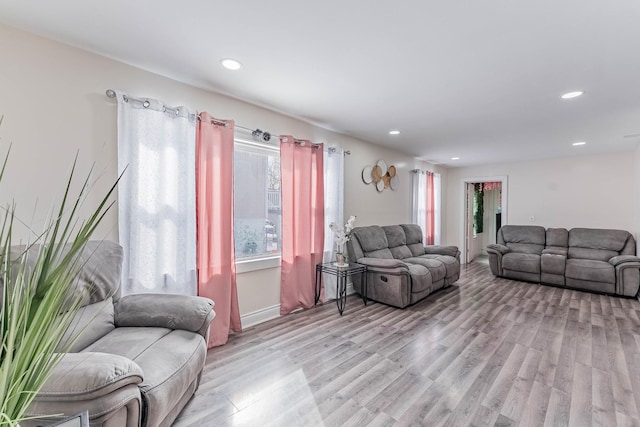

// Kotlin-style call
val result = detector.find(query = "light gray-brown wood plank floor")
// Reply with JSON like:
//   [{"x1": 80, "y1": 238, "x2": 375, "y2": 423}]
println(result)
[{"x1": 171, "y1": 263, "x2": 640, "y2": 427}]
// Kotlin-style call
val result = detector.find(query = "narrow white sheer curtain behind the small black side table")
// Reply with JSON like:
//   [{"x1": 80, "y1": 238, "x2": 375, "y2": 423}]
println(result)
[{"x1": 322, "y1": 144, "x2": 344, "y2": 301}]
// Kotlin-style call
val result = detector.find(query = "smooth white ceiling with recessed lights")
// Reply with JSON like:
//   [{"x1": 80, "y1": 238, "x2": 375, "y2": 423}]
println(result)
[{"x1": 0, "y1": 0, "x2": 640, "y2": 166}]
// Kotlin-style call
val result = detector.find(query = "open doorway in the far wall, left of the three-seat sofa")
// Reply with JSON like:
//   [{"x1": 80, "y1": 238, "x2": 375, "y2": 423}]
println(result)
[{"x1": 460, "y1": 176, "x2": 508, "y2": 264}]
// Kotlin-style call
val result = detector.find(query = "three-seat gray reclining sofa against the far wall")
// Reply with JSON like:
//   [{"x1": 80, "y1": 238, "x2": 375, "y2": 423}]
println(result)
[{"x1": 487, "y1": 225, "x2": 640, "y2": 296}]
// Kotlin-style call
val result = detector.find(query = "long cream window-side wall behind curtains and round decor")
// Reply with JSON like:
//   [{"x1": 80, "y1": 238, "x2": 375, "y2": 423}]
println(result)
[{"x1": 0, "y1": 26, "x2": 436, "y2": 320}]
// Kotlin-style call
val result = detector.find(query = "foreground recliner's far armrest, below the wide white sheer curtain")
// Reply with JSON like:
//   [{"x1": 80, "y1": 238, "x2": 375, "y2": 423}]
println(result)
[{"x1": 114, "y1": 294, "x2": 215, "y2": 337}]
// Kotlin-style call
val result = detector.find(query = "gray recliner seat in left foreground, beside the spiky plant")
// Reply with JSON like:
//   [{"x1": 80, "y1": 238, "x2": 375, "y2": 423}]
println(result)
[{"x1": 20, "y1": 241, "x2": 215, "y2": 427}]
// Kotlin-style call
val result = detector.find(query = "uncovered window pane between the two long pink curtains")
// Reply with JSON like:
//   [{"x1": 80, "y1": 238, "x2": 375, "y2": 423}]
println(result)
[{"x1": 233, "y1": 139, "x2": 282, "y2": 261}]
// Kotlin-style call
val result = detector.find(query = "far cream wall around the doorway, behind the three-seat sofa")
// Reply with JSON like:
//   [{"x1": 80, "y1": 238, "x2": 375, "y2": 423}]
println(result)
[{"x1": 446, "y1": 153, "x2": 639, "y2": 252}]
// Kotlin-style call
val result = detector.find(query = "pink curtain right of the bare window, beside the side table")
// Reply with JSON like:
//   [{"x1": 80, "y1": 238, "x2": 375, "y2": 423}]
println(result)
[{"x1": 280, "y1": 136, "x2": 324, "y2": 314}]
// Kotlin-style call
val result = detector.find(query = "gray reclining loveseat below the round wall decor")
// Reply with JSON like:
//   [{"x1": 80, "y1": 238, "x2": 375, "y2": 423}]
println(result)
[{"x1": 347, "y1": 224, "x2": 460, "y2": 307}]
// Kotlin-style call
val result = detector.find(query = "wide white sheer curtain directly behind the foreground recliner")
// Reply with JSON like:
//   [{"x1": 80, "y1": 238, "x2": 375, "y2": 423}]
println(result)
[{"x1": 116, "y1": 92, "x2": 197, "y2": 295}]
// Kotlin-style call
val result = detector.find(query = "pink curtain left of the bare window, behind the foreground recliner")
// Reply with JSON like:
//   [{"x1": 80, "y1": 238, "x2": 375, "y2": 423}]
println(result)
[{"x1": 196, "y1": 113, "x2": 242, "y2": 347}]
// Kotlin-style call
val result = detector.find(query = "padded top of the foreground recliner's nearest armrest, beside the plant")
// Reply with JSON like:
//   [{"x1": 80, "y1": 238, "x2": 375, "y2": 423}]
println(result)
[{"x1": 38, "y1": 352, "x2": 143, "y2": 402}]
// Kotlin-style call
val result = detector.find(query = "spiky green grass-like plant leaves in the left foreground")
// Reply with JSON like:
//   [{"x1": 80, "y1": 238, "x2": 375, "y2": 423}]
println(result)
[{"x1": 0, "y1": 145, "x2": 117, "y2": 426}]
